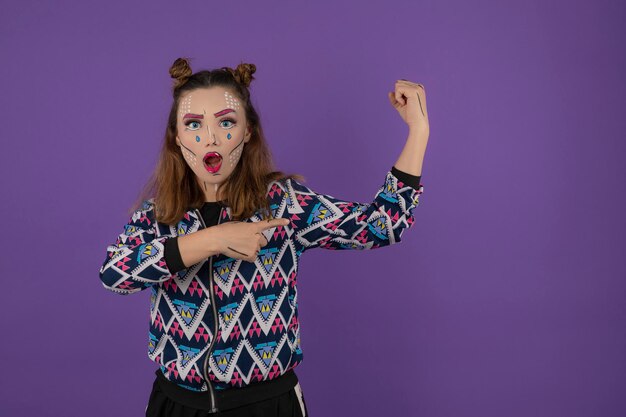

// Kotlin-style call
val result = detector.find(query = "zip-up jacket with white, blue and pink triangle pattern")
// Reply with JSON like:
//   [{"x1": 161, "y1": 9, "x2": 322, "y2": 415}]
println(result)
[{"x1": 100, "y1": 167, "x2": 424, "y2": 394}]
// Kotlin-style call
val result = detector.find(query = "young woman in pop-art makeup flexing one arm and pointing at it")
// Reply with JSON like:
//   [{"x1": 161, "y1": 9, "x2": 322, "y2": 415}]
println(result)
[{"x1": 100, "y1": 58, "x2": 429, "y2": 417}]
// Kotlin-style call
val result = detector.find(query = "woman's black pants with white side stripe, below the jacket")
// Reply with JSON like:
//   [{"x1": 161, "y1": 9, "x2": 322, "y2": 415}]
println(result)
[{"x1": 146, "y1": 370, "x2": 309, "y2": 417}]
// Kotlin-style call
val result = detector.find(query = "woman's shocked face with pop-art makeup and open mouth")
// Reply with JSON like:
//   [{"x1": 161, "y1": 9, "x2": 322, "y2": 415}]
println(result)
[{"x1": 176, "y1": 87, "x2": 250, "y2": 201}]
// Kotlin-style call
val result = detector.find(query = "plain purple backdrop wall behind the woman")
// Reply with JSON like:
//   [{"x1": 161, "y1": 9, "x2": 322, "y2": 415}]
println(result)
[{"x1": 0, "y1": 0, "x2": 626, "y2": 417}]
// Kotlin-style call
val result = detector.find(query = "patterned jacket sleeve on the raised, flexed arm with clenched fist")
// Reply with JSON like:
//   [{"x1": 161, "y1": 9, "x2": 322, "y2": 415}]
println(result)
[{"x1": 287, "y1": 167, "x2": 424, "y2": 251}]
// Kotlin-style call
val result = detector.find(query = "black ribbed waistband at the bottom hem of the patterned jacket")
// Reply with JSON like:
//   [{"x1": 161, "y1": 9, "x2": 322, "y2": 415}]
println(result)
[{"x1": 155, "y1": 368, "x2": 298, "y2": 411}]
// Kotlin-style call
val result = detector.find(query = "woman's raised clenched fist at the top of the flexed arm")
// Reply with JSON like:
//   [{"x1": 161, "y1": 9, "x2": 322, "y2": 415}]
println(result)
[{"x1": 388, "y1": 80, "x2": 430, "y2": 135}]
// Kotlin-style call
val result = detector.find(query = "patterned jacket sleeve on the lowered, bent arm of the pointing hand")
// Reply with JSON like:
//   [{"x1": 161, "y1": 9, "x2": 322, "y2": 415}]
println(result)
[{"x1": 100, "y1": 200, "x2": 172, "y2": 295}]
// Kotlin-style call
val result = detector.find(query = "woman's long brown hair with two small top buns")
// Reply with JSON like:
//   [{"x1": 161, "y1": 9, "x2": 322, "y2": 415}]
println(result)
[{"x1": 130, "y1": 58, "x2": 304, "y2": 225}]
